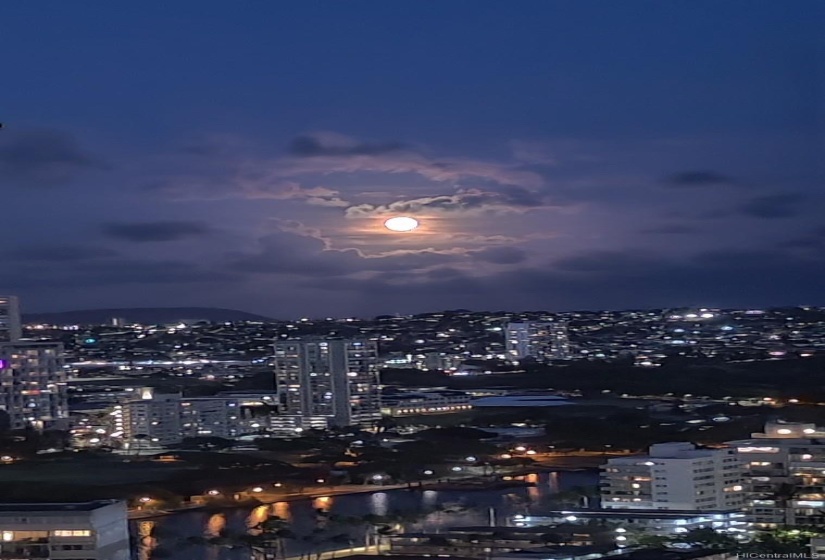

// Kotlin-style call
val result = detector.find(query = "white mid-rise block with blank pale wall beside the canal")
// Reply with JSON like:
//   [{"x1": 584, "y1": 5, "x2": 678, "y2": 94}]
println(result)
[{"x1": 601, "y1": 442, "x2": 744, "y2": 511}]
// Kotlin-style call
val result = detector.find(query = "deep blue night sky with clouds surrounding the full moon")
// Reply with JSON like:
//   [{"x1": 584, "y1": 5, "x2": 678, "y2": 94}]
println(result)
[{"x1": 0, "y1": 0, "x2": 825, "y2": 317}]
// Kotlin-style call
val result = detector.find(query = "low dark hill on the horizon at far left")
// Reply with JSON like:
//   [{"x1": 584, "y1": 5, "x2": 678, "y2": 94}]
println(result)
[{"x1": 23, "y1": 307, "x2": 272, "y2": 325}]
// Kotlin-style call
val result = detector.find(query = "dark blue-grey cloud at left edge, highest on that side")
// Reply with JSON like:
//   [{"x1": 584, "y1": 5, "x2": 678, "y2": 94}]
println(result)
[{"x1": 0, "y1": 130, "x2": 107, "y2": 187}]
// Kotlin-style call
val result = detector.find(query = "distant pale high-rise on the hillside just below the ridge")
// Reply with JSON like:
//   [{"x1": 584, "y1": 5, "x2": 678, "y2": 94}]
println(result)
[{"x1": 505, "y1": 321, "x2": 571, "y2": 361}]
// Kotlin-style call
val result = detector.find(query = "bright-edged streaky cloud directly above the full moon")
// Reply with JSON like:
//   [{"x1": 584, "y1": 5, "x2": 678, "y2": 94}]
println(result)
[{"x1": 346, "y1": 186, "x2": 546, "y2": 218}]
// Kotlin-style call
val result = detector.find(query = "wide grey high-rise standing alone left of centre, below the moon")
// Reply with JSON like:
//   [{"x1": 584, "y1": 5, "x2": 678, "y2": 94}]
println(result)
[{"x1": 275, "y1": 338, "x2": 381, "y2": 426}]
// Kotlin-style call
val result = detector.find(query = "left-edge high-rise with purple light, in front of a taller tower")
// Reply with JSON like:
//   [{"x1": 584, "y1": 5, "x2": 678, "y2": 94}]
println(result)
[{"x1": 0, "y1": 340, "x2": 69, "y2": 429}]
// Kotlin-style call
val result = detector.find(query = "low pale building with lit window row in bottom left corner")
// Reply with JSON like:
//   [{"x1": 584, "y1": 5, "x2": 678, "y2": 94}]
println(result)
[{"x1": 0, "y1": 500, "x2": 130, "y2": 560}]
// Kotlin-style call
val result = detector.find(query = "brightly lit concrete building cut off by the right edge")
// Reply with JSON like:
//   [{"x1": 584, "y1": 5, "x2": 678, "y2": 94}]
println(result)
[{"x1": 728, "y1": 422, "x2": 825, "y2": 529}]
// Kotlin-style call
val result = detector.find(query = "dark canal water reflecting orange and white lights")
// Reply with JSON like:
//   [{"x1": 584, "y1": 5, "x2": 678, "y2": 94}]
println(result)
[{"x1": 132, "y1": 471, "x2": 598, "y2": 560}]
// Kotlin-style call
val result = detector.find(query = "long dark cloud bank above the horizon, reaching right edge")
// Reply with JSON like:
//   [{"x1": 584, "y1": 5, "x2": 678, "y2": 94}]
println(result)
[{"x1": 308, "y1": 246, "x2": 825, "y2": 313}]
